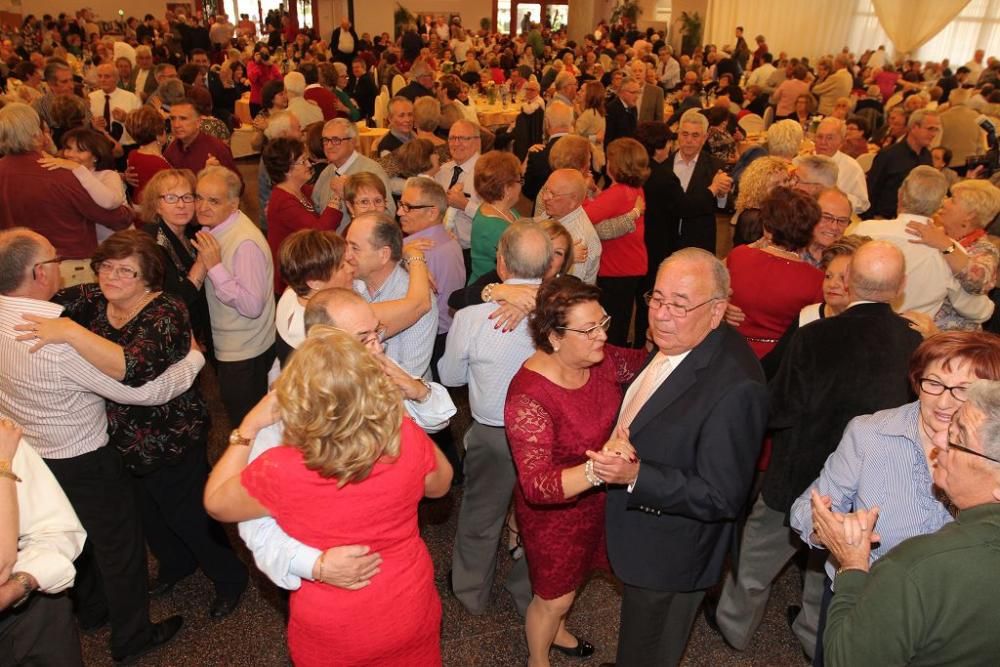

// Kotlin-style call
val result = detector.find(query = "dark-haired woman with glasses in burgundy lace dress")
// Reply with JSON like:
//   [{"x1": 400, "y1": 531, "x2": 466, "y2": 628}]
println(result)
[{"x1": 504, "y1": 276, "x2": 648, "y2": 667}]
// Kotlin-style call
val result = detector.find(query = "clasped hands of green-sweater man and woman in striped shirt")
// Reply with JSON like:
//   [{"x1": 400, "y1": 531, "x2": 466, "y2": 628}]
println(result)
[{"x1": 811, "y1": 489, "x2": 882, "y2": 572}]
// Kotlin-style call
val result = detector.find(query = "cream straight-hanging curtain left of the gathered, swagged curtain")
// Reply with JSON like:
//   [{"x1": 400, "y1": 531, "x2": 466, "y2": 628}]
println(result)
[{"x1": 705, "y1": 0, "x2": 860, "y2": 62}]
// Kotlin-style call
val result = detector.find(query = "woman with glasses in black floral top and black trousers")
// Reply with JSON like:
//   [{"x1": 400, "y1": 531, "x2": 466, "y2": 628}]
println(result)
[{"x1": 18, "y1": 230, "x2": 248, "y2": 618}]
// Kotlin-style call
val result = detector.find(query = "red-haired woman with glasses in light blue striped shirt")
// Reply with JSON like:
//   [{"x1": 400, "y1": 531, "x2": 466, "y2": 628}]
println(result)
[{"x1": 790, "y1": 332, "x2": 1000, "y2": 664}]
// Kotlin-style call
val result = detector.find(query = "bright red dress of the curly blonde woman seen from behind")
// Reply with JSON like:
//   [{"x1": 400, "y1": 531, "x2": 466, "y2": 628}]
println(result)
[{"x1": 242, "y1": 418, "x2": 441, "y2": 667}]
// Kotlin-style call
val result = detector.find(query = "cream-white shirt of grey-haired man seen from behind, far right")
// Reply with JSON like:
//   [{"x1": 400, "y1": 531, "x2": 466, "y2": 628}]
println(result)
[{"x1": 853, "y1": 213, "x2": 993, "y2": 322}]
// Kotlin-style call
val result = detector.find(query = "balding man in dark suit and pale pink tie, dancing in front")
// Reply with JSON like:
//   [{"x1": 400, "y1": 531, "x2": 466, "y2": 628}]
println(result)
[{"x1": 588, "y1": 248, "x2": 767, "y2": 667}]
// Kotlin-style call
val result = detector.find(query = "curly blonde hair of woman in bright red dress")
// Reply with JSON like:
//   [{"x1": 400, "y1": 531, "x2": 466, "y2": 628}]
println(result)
[{"x1": 275, "y1": 325, "x2": 403, "y2": 487}]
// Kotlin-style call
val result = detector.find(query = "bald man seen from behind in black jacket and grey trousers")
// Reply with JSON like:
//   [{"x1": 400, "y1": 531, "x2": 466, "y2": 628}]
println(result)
[{"x1": 706, "y1": 241, "x2": 922, "y2": 656}]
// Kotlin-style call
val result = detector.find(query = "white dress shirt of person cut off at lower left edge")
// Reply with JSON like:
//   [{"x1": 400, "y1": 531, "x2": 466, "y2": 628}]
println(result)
[{"x1": 9, "y1": 439, "x2": 87, "y2": 594}]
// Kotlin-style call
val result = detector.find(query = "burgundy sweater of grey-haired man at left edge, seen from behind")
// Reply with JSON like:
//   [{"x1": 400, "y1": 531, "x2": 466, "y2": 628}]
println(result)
[{"x1": 0, "y1": 153, "x2": 132, "y2": 259}]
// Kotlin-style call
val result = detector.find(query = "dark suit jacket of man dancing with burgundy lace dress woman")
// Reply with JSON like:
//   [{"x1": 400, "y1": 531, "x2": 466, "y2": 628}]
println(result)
[{"x1": 606, "y1": 323, "x2": 767, "y2": 592}]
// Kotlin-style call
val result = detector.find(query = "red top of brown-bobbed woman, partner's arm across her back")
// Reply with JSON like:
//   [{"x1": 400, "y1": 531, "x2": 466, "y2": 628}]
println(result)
[{"x1": 583, "y1": 183, "x2": 648, "y2": 278}]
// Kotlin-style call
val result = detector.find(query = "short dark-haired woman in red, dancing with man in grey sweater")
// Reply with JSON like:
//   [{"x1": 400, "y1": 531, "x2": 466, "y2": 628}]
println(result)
[{"x1": 263, "y1": 138, "x2": 344, "y2": 294}]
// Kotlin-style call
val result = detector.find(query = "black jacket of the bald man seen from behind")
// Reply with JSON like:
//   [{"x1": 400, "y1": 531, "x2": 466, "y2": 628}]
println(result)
[{"x1": 761, "y1": 303, "x2": 922, "y2": 512}]
